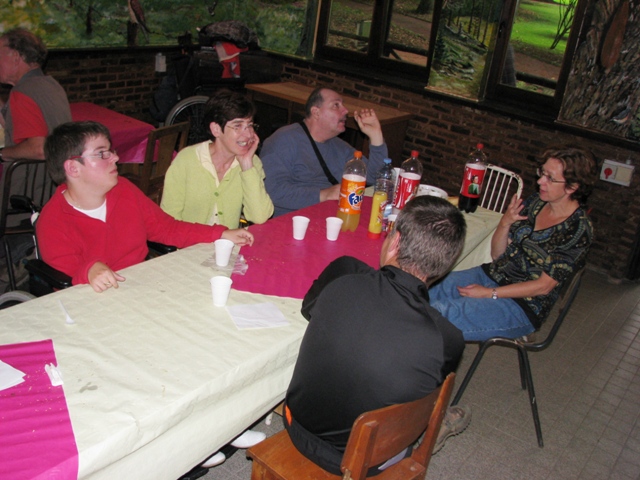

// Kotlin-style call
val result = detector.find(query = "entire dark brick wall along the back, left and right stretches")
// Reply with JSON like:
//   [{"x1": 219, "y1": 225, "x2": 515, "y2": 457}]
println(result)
[{"x1": 41, "y1": 49, "x2": 640, "y2": 279}]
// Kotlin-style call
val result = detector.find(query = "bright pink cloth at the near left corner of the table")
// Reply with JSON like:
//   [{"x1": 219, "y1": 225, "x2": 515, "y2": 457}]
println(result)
[{"x1": 0, "y1": 340, "x2": 78, "y2": 480}]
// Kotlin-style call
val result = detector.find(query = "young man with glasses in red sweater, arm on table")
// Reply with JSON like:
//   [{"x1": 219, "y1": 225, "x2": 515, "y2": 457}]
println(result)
[{"x1": 36, "y1": 122, "x2": 253, "y2": 292}]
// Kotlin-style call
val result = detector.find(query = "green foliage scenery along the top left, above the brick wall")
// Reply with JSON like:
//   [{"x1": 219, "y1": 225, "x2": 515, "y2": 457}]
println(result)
[{"x1": 0, "y1": 0, "x2": 306, "y2": 53}]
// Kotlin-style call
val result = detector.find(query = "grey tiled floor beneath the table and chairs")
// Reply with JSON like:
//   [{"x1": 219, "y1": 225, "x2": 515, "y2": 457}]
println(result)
[{"x1": 195, "y1": 272, "x2": 640, "y2": 480}]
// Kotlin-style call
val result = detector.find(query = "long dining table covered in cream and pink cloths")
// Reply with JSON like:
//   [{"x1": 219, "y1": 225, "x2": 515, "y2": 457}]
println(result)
[{"x1": 0, "y1": 190, "x2": 500, "y2": 479}]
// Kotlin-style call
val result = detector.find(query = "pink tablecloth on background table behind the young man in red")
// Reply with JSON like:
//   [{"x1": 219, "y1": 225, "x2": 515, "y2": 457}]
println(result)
[{"x1": 71, "y1": 102, "x2": 154, "y2": 163}]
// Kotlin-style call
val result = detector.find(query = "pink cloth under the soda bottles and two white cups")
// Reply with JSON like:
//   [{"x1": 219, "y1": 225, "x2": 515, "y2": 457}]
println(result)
[{"x1": 232, "y1": 197, "x2": 382, "y2": 298}]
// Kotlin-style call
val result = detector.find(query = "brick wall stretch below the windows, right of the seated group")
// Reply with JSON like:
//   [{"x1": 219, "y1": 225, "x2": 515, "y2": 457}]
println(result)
[{"x1": 283, "y1": 62, "x2": 640, "y2": 279}]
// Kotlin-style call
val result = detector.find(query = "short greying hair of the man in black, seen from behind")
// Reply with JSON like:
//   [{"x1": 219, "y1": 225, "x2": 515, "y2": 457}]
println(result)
[{"x1": 394, "y1": 195, "x2": 467, "y2": 283}]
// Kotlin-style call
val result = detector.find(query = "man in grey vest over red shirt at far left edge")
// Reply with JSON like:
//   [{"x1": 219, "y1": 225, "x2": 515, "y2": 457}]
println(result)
[{"x1": 0, "y1": 28, "x2": 71, "y2": 160}]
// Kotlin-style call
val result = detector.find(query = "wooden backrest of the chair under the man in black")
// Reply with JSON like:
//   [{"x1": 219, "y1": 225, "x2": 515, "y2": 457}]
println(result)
[{"x1": 341, "y1": 373, "x2": 455, "y2": 480}]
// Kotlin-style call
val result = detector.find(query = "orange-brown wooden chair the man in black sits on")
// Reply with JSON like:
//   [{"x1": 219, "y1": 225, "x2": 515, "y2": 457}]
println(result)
[{"x1": 247, "y1": 373, "x2": 455, "y2": 480}]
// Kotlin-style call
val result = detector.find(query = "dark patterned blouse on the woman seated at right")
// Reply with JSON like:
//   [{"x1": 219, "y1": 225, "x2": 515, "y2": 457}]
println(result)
[{"x1": 482, "y1": 193, "x2": 593, "y2": 330}]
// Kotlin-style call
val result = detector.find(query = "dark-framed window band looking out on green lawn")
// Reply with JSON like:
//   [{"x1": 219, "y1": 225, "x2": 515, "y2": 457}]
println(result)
[{"x1": 316, "y1": 0, "x2": 586, "y2": 111}]
